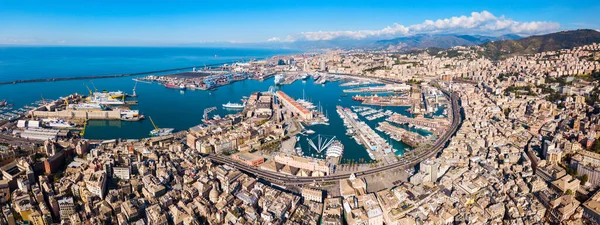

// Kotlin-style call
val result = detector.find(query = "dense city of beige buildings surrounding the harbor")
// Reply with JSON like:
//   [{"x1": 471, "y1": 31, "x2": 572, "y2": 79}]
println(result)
[{"x1": 0, "y1": 44, "x2": 600, "y2": 225}]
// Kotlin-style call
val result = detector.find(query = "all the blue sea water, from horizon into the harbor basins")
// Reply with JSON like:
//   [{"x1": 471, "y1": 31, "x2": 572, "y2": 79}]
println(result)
[{"x1": 0, "y1": 47, "x2": 434, "y2": 162}]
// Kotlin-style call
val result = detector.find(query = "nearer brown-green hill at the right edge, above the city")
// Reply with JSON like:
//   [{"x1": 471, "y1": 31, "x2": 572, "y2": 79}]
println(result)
[{"x1": 481, "y1": 29, "x2": 600, "y2": 59}]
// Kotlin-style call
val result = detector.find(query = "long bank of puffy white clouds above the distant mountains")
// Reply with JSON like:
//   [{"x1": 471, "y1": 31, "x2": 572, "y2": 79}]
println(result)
[{"x1": 278, "y1": 10, "x2": 560, "y2": 41}]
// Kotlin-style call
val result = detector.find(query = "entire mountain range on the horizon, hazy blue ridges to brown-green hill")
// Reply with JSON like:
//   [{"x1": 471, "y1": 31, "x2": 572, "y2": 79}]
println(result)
[{"x1": 185, "y1": 29, "x2": 600, "y2": 59}]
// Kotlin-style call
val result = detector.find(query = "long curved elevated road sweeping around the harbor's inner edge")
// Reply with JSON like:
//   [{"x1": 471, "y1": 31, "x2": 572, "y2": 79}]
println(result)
[{"x1": 208, "y1": 86, "x2": 462, "y2": 185}]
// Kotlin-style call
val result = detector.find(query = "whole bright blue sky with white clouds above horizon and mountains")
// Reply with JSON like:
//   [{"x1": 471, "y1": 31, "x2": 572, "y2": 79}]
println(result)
[{"x1": 0, "y1": 0, "x2": 600, "y2": 46}]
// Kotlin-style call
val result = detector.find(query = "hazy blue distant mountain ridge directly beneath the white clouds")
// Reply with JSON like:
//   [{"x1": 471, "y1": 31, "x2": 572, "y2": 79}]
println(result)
[{"x1": 376, "y1": 34, "x2": 521, "y2": 50}]
